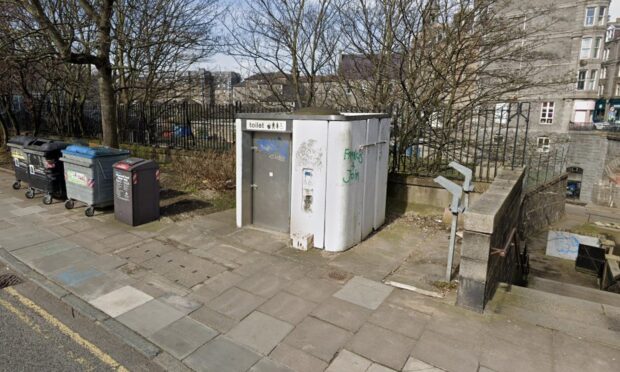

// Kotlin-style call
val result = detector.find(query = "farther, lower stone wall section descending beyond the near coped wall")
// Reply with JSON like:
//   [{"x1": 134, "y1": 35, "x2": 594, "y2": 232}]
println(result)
[{"x1": 521, "y1": 174, "x2": 568, "y2": 236}]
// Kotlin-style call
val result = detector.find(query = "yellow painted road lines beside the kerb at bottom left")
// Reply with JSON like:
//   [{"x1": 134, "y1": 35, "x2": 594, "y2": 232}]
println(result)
[{"x1": 0, "y1": 287, "x2": 128, "y2": 372}]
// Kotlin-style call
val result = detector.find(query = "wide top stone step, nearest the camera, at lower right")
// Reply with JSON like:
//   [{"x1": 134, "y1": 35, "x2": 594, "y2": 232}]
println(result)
[{"x1": 485, "y1": 284, "x2": 620, "y2": 355}]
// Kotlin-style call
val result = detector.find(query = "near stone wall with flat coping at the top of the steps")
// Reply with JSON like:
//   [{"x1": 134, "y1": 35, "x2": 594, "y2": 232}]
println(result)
[{"x1": 457, "y1": 168, "x2": 525, "y2": 312}]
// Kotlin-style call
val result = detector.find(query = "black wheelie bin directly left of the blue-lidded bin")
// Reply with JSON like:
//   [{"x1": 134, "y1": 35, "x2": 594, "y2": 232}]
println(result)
[{"x1": 24, "y1": 138, "x2": 69, "y2": 204}]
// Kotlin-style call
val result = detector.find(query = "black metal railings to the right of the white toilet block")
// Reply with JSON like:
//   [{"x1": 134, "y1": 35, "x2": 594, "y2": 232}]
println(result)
[{"x1": 392, "y1": 103, "x2": 530, "y2": 182}]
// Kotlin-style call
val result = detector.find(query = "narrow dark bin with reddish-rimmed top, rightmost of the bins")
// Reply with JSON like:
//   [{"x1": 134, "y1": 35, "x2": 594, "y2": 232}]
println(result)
[{"x1": 114, "y1": 158, "x2": 159, "y2": 226}]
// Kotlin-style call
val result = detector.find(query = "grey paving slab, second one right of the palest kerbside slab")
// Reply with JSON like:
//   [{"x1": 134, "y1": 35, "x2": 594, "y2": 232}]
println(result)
[{"x1": 150, "y1": 317, "x2": 219, "y2": 360}]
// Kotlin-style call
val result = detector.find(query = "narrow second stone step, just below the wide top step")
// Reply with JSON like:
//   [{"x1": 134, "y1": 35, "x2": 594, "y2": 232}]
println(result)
[{"x1": 528, "y1": 276, "x2": 620, "y2": 307}]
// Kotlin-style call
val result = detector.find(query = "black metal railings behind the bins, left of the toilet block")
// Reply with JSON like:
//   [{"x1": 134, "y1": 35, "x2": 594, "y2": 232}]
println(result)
[{"x1": 0, "y1": 101, "x2": 284, "y2": 150}]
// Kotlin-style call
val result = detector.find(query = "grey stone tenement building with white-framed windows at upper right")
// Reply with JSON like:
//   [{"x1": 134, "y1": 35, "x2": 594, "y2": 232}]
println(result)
[{"x1": 502, "y1": 0, "x2": 618, "y2": 202}]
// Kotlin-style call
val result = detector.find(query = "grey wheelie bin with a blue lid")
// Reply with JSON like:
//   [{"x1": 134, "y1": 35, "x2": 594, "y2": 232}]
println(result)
[{"x1": 60, "y1": 145, "x2": 129, "y2": 217}]
